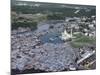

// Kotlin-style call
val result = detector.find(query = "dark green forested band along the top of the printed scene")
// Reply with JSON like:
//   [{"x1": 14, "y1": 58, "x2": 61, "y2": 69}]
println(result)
[{"x1": 11, "y1": 1, "x2": 96, "y2": 16}]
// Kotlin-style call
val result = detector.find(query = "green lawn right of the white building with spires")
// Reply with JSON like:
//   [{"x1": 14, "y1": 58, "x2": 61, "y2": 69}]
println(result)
[{"x1": 70, "y1": 35, "x2": 96, "y2": 48}]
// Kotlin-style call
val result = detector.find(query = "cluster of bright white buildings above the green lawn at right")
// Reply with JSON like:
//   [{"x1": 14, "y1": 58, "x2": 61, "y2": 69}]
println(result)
[{"x1": 65, "y1": 16, "x2": 96, "y2": 37}]
